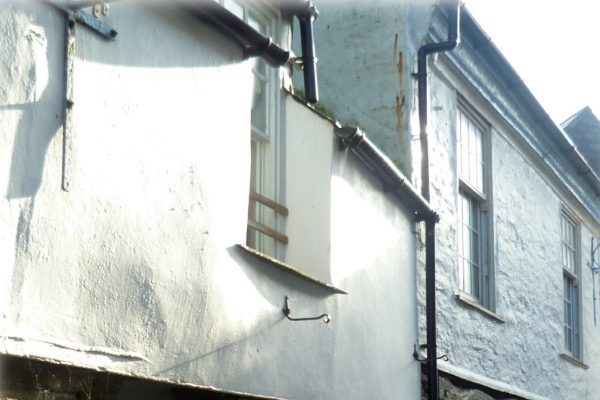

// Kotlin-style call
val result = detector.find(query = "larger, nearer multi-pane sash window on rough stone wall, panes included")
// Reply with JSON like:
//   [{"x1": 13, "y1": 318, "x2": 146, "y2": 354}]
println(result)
[{"x1": 456, "y1": 97, "x2": 495, "y2": 311}]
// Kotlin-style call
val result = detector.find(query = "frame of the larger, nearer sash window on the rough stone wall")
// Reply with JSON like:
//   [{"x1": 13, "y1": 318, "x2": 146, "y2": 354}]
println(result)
[{"x1": 455, "y1": 95, "x2": 496, "y2": 312}]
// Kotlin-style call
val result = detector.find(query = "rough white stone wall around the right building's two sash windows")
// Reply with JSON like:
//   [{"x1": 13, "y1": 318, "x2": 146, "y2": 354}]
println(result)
[{"x1": 419, "y1": 63, "x2": 598, "y2": 399}]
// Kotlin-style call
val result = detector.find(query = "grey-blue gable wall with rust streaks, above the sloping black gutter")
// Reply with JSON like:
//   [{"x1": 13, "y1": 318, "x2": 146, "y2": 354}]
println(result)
[{"x1": 315, "y1": 0, "x2": 432, "y2": 176}]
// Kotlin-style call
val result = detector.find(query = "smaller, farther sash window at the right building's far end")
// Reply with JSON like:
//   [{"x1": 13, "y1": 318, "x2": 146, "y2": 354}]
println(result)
[{"x1": 560, "y1": 208, "x2": 583, "y2": 360}]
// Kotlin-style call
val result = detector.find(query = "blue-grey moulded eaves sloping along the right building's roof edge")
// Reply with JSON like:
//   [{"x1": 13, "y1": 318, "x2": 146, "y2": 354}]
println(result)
[{"x1": 429, "y1": 7, "x2": 600, "y2": 223}]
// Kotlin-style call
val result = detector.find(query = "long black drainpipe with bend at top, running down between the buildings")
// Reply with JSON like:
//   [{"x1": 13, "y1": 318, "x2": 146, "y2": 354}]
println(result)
[{"x1": 417, "y1": 0, "x2": 462, "y2": 400}]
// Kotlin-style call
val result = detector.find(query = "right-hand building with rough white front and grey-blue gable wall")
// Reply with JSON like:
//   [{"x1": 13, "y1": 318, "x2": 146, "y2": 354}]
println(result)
[{"x1": 316, "y1": 1, "x2": 600, "y2": 400}]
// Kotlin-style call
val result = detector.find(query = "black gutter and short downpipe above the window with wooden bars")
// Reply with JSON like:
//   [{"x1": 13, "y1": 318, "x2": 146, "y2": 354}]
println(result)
[{"x1": 184, "y1": 0, "x2": 319, "y2": 103}]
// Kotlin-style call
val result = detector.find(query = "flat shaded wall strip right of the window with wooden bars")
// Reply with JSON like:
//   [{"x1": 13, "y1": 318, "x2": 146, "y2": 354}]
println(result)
[{"x1": 285, "y1": 100, "x2": 337, "y2": 282}]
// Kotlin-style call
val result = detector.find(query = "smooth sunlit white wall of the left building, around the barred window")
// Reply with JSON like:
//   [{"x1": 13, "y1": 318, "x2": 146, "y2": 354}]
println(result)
[{"x1": 0, "y1": 1, "x2": 420, "y2": 399}]
